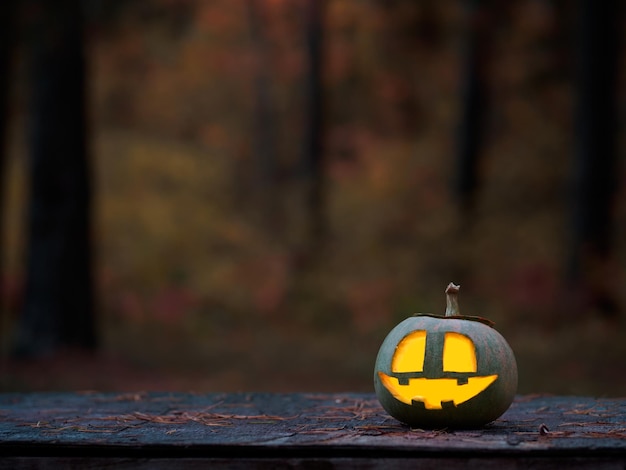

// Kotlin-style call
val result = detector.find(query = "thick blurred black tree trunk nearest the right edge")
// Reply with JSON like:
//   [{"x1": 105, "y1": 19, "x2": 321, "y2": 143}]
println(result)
[{"x1": 568, "y1": 0, "x2": 620, "y2": 315}]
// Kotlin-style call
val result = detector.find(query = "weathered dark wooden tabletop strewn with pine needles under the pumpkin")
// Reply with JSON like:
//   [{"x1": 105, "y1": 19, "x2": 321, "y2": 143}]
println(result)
[{"x1": 0, "y1": 393, "x2": 626, "y2": 470}]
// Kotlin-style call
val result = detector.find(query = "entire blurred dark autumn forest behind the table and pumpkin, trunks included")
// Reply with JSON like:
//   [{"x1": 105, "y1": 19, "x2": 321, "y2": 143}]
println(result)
[{"x1": 0, "y1": 0, "x2": 626, "y2": 396}]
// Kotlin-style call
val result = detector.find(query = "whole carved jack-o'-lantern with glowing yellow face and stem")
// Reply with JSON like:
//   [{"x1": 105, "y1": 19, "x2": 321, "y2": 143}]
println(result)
[{"x1": 374, "y1": 284, "x2": 517, "y2": 428}]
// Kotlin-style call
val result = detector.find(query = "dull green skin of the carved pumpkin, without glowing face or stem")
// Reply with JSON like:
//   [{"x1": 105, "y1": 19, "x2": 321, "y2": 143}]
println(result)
[{"x1": 374, "y1": 314, "x2": 517, "y2": 429}]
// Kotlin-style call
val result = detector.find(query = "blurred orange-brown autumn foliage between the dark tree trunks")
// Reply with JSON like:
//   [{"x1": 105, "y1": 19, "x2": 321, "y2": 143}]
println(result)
[{"x1": 4, "y1": 0, "x2": 626, "y2": 393}]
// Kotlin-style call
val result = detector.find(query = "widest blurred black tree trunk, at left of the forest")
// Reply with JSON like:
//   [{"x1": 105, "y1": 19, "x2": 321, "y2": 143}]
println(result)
[{"x1": 15, "y1": 0, "x2": 96, "y2": 355}]
